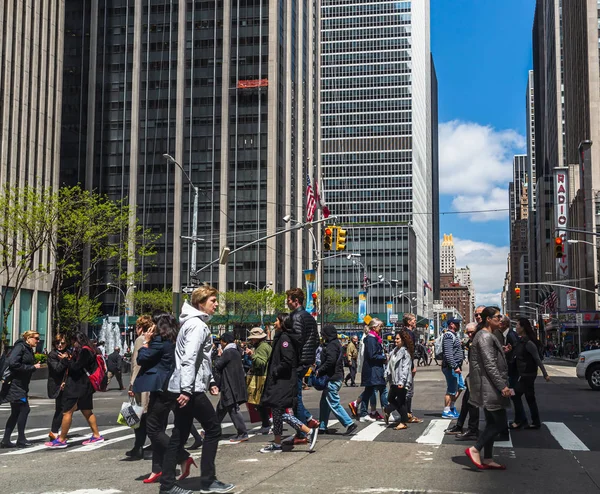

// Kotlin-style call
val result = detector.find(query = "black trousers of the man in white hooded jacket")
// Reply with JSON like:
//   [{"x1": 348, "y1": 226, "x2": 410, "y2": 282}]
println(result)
[{"x1": 160, "y1": 393, "x2": 221, "y2": 490}]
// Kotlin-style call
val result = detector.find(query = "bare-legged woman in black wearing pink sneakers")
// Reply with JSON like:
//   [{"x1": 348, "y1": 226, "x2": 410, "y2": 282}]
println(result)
[{"x1": 45, "y1": 331, "x2": 104, "y2": 449}]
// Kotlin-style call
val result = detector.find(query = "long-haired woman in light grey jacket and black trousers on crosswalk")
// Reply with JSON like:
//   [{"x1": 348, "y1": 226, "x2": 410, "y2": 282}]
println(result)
[{"x1": 383, "y1": 329, "x2": 415, "y2": 431}]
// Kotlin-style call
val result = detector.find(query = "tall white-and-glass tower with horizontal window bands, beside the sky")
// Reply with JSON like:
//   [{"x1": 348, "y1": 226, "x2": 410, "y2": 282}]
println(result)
[{"x1": 320, "y1": 0, "x2": 439, "y2": 314}]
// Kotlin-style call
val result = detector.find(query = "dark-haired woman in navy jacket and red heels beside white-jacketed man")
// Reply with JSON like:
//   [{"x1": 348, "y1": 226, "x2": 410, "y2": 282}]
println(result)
[{"x1": 133, "y1": 313, "x2": 194, "y2": 484}]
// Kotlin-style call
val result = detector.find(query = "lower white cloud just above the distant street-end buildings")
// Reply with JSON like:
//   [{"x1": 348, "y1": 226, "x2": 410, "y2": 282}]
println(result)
[{"x1": 454, "y1": 237, "x2": 509, "y2": 305}]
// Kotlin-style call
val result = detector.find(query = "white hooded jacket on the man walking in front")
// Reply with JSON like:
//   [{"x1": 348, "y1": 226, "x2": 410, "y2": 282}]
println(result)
[{"x1": 169, "y1": 302, "x2": 213, "y2": 395}]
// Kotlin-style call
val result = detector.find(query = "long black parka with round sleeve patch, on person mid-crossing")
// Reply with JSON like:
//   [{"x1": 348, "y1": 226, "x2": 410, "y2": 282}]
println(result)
[{"x1": 261, "y1": 331, "x2": 299, "y2": 408}]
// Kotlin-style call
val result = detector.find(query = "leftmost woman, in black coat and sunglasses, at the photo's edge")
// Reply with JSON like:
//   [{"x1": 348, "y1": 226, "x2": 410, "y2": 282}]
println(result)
[{"x1": 0, "y1": 331, "x2": 40, "y2": 448}]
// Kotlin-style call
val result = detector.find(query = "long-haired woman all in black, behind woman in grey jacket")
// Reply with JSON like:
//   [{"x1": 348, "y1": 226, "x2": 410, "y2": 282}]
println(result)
[{"x1": 510, "y1": 317, "x2": 550, "y2": 429}]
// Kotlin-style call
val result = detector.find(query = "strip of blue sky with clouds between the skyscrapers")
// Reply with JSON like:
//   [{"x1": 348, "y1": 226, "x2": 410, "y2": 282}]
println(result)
[{"x1": 431, "y1": 0, "x2": 535, "y2": 302}]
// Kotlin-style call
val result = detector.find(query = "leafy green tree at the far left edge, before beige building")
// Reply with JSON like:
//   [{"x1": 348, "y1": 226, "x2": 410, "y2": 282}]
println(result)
[{"x1": 0, "y1": 186, "x2": 57, "y2": 352}]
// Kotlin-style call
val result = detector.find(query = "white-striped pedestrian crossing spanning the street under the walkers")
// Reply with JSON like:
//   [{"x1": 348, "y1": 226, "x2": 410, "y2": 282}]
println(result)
[{"x1": 0, "y1": 412, "x2": 600, "y2": 456}]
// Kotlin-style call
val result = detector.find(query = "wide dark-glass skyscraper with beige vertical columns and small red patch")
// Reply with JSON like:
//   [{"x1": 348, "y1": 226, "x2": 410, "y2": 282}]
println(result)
[{"x1": 62, "y1": 0, "x2": 318, "y2": 308}]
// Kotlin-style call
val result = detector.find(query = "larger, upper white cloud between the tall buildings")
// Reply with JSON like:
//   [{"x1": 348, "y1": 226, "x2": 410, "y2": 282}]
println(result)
[{"x1": 439, "y1": 120, "x2": 525, "y2": 221}]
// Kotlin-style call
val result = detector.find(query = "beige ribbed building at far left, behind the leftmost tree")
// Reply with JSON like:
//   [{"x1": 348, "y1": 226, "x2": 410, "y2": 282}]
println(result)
[{"x1": 0, "y1": 0, "x2": 64, "y2": 351}]
